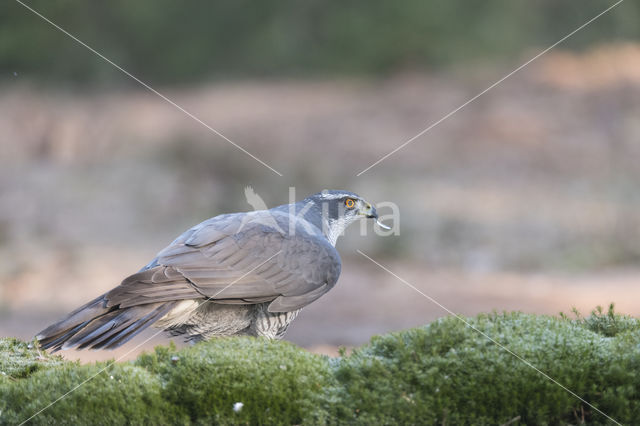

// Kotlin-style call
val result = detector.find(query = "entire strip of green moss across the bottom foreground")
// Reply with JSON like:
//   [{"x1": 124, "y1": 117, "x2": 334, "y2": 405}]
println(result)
[{"x1": 0, "y1": 307, "x2": 640, "y2": 425}]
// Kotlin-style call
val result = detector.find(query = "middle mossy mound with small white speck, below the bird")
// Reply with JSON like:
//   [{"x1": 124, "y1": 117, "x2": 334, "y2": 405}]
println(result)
[{"x1": 136, "y1": 337, "x2": 332, "y2": 424}]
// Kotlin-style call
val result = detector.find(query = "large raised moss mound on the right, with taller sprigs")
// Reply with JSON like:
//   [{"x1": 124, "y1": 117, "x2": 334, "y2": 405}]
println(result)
[{"x1": 336, "y1": 313, "x2": 640, "y2": 425}]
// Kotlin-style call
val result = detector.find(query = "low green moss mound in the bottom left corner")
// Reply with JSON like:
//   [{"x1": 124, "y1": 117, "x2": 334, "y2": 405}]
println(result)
[{"x1": 0, "y1": 362, "x2": 183, "y2": 425}]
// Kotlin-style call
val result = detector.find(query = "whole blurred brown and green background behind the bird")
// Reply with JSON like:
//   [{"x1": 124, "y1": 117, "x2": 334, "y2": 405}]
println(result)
[{"x1": 0, "y1": 0, "x2": 640, "y2": 360}]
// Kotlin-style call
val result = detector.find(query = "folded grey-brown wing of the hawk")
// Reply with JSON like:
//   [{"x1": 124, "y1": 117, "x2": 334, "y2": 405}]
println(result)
[{"x1": 101, "y1": 212, "x2": 340, "y2": 312}]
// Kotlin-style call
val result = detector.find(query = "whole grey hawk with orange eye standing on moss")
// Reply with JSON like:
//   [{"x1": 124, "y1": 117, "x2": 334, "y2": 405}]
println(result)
[{"x1": 36, "y1": 190, "x2": 383, "y2": 351}]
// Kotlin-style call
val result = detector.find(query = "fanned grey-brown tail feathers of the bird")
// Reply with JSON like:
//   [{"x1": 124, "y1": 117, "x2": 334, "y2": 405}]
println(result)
[{"x1": 36, "y1": 295, "x2": 177, "y2": 352}]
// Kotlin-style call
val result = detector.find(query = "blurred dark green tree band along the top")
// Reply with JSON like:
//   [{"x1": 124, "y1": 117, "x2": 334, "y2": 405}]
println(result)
[{"x1": 0, "y1": 0, "x2": 640, "y2": 84}]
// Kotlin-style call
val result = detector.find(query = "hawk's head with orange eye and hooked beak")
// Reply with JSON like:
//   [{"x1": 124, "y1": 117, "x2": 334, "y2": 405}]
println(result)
[{"x1": 304, "y1": 190, "x2": 387, "y2": 245}]
